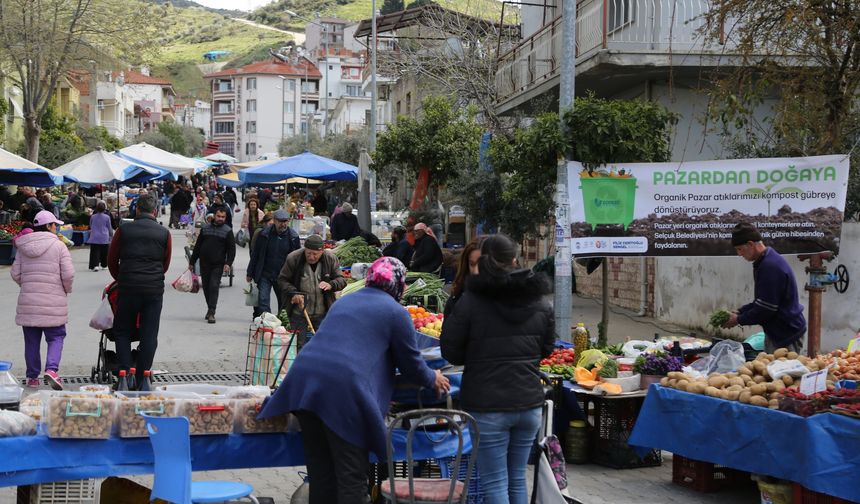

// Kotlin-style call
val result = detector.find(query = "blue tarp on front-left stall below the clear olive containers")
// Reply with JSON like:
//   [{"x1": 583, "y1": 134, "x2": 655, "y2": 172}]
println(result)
[{"x1": 0, "y1": 432, "x2": 471, "y2": 486}]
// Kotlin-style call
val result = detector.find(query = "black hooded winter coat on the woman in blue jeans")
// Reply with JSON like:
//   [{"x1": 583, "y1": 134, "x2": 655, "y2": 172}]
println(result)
[{"x1": 440, "y1": 270, "x2": 555, "y2": 412}]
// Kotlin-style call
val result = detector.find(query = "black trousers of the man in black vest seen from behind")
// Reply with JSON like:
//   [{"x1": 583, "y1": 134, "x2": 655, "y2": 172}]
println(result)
[{"x1": 113, "y1": 291, "x2": 164, "y2": 383}]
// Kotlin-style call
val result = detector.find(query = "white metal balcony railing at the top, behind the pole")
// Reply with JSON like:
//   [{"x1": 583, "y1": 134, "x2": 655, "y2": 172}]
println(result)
[{"x1": 496, "y1": 0, "x2": 728, "y2": 103}]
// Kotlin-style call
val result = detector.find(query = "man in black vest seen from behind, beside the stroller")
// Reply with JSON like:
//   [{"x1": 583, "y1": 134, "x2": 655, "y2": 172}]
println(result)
[{"x1": 108, "y1": 194, "x2": 172, "y2": 383}]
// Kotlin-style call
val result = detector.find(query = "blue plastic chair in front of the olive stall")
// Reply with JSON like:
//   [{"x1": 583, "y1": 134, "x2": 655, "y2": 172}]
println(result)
[{"x1": 142, "y1": 414, "x2": 259, "y2": 504}]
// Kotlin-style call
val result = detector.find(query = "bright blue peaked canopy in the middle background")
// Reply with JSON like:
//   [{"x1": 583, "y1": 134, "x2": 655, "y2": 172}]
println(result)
[{"x1": 239, "y1": 151, "x2": 358, "y2": 184}]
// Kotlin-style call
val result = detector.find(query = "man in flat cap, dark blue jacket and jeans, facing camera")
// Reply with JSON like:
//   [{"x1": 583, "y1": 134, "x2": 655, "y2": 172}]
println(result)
[{"x1": 246, "y1": 208, "x2": 301, "y2": 317}]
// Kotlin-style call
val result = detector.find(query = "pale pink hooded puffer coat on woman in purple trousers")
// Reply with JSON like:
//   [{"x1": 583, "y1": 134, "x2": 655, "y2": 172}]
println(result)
[{"x1": 12, "y1": 231, "x2": 75, "y2": 327}]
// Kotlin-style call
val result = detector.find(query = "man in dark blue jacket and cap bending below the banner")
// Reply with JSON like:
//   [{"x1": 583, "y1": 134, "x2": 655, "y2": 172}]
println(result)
[{"x1": 724, "y1": 222, "x2": 806, "y2": 353}]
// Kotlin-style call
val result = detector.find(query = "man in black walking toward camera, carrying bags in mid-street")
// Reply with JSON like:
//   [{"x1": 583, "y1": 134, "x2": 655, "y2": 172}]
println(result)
[{"x1": 188, "y1": 208, "x2": 236, "y2": 324}]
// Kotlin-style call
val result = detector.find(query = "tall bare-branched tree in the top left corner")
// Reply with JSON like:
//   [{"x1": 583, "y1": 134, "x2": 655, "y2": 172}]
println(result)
[{"x1": 0, "y1": 0, "x2": 163, "y2": 161}]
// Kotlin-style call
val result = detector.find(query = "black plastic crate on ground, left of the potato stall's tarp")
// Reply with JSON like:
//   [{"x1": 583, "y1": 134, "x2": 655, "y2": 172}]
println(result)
[{"x1": 590, "y1": 396, "x2": 663, "y2": 469}]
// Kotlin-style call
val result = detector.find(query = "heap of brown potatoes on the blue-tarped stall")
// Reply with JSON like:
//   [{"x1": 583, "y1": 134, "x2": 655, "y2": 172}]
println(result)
[{"x1": 660, "y1": 348, "x2": 835, "y2": 409}]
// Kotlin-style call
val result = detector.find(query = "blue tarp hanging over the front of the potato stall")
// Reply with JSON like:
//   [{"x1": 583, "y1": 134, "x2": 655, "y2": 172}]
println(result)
[{"x1": 629, "y1": 385, "x2": 860, "y2": 501}]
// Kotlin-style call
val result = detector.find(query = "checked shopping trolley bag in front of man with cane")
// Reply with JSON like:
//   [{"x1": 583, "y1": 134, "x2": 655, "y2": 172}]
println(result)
[{"x1": 245, "y1": 325, "x2": 298, "y2": 387}]
